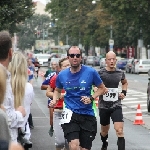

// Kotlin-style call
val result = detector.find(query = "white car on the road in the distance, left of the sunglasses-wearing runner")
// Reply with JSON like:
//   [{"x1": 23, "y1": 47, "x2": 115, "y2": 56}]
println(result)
[{"x1": 34, "y1": 54, "x2": 50, "y2": 66}]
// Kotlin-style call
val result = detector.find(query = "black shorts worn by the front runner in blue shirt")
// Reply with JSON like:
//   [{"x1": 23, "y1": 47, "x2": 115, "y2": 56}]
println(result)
[{"x1": 61, "y1": 113, "x2": 97, "y2": 150}]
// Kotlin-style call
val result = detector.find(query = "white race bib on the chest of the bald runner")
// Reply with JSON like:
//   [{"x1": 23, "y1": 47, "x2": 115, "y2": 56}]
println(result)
[{"x1": 103, "y1": 88, "x2": 118, "y2": 102}]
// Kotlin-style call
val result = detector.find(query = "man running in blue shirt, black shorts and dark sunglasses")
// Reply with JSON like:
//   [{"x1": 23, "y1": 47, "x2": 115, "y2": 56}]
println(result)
[{"x1": 50, "y1": 46, "x2": 107, "y2": 150}]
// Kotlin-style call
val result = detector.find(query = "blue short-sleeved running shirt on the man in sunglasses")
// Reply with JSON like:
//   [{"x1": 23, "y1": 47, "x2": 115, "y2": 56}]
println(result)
[{"x1": 56, "y1": 65, "x2": 102, "y2": 116}]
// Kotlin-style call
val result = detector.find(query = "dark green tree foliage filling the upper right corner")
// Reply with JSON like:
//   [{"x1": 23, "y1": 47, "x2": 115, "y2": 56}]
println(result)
[{"x1": 101, "y1": 0, "x2": 150, "y2": 45}]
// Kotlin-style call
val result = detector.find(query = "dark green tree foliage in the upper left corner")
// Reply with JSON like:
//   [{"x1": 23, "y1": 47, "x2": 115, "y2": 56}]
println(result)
[{"x1": 0, "y1": 0, "x2": 34, "y2": 33}]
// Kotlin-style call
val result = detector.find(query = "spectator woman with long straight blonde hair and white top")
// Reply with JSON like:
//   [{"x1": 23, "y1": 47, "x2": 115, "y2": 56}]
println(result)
[{"x1": 8, "y1": 52, "x2": 34, "y2": 144}]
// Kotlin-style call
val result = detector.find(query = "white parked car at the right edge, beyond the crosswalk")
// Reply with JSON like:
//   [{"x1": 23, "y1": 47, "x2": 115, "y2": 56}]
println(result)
[{"x1": 135, "y1": 59, "x2": 150, "y2": 74}]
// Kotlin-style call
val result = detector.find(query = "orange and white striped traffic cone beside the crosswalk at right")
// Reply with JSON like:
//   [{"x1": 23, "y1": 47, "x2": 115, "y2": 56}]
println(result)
[{"x1": 133, "y1": 104, "x2": 145, "y2": 125}]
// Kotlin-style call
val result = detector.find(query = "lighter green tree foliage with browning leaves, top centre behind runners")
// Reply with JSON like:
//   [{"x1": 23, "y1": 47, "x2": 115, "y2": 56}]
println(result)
[{"x1": 46, "y1": 0, "x2": 110, "y2": 46}]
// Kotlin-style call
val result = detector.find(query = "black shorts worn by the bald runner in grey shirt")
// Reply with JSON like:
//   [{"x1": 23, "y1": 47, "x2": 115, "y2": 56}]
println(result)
[{"x1": 99, "y1": 107, "x2": 124, "y2": 126}]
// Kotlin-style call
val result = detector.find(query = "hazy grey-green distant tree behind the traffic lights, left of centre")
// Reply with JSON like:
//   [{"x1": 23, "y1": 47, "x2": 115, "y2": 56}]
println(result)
[{"x1": 17, "y1": 14, "x2": 50, "y2": 50}]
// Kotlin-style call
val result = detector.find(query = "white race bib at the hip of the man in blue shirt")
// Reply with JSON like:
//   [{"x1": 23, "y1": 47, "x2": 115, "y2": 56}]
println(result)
[{"x1": 59, "y1": 108, "x2": 73, "y2": 125}]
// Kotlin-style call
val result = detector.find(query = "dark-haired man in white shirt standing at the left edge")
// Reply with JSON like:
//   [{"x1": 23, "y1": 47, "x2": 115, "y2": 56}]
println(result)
[{"x1": 0, "y1": 31, "x2": 26, "y2": 142}]
